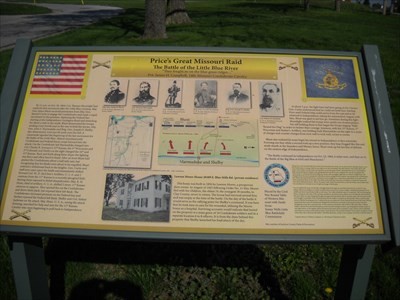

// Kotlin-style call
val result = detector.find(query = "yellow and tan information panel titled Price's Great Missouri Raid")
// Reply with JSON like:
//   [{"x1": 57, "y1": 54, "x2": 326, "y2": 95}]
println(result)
[{"x1": 1, "y1": 51, "x2": 384, "y2": 235}]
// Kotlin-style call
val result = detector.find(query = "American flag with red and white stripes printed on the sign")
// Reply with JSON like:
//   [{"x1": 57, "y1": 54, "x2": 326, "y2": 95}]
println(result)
[{"x1": 30, "y1": 54, "x2": 88, "y2": 95}]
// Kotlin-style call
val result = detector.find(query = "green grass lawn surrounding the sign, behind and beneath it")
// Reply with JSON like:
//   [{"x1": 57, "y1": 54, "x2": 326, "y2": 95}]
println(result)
[{"x1": 0, "y1": 0, "x2": 400, "y2": 299}]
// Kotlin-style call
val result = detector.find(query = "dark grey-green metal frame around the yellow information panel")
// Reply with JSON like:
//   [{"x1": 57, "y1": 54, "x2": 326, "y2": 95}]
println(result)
[{"x1": 0, "y1": 40, "x2": 400, "y2": 245}]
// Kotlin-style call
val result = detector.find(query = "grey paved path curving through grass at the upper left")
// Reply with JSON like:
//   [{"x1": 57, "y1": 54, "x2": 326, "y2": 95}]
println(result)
[{"x1": 0, "y1": 1, "x2": 123, "y2": 50}]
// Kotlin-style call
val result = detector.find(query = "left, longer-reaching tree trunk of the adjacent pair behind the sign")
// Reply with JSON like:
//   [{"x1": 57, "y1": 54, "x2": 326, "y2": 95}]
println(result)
[{"x1": 143, "y1": 0, "x2": 167, "y2": 39}]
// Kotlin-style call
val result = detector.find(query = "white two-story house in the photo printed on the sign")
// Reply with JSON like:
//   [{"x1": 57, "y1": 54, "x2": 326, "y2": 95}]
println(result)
[{"x1": 116, "y1": 175, "x2": 171, "y2": 212}]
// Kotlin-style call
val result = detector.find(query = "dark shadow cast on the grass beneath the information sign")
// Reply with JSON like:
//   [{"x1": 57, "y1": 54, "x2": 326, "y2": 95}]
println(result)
[{"x1": 46, "y1": 238, "x2": 287, "y2": 300}]
